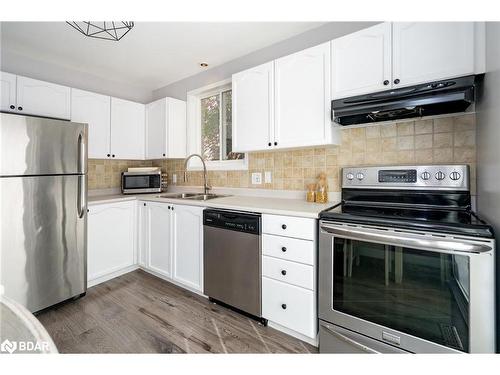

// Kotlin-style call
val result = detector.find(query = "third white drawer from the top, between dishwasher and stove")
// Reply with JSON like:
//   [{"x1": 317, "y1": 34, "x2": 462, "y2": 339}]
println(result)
[{"x1": 262, "y1": 256, "x2": 314, "y2": 290}]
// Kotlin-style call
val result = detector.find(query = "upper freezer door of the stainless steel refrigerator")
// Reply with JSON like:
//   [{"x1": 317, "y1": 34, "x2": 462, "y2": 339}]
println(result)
[{"x1": 0, "y1": 113, "x2": 87, "y2": 176}]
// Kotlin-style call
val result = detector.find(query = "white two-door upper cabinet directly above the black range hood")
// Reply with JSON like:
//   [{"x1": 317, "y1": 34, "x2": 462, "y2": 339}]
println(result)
[{"x1": 332, "y1": 22, "x2": 485, "y2": 99}]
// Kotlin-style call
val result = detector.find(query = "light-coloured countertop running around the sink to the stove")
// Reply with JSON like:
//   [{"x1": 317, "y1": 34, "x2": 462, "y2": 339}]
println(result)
[{"x1": 88, "y1": 193, "x2": 336, "y2": 219}]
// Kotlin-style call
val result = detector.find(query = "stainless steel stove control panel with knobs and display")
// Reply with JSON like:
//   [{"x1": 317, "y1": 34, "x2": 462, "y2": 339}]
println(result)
[{"x1": 342, "y1": 165, "x2": 469, "y2": 190}]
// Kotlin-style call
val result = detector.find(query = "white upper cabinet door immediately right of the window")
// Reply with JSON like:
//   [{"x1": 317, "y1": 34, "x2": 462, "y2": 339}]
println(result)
[{"x1": 232, "y1": 62, "x2": 274, "y2": 152}]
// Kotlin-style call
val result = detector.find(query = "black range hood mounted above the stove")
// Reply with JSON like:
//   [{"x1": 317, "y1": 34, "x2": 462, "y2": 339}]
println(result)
[{"x1": 332, "y1": 75, "x2": 483, "y2": 126}]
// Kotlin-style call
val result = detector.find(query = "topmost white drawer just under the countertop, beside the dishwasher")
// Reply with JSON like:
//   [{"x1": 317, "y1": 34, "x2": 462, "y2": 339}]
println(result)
[{"x1": 262, "y1": 215, "x2": 316, "y2": 240}]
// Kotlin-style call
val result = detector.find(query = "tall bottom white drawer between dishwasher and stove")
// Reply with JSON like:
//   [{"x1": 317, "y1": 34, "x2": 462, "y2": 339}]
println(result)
[{"x1": 262, "y1": 277, "x2": 317, "y2": 338}]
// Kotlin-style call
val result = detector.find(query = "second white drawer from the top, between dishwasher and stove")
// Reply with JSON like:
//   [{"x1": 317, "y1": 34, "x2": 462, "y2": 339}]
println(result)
[{"x1": 262, "y1": 234, "x2": 316, "y2": 266}]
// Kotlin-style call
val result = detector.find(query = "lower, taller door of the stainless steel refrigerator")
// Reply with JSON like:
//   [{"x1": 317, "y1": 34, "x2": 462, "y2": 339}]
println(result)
[{"x1": 0, "y1": 175, "x2": 87, "y2": 312}]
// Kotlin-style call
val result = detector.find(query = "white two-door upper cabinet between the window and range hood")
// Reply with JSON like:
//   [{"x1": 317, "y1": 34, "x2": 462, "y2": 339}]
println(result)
[{"x1": 233, "y1": 42, "x2": 339, "y2": 152}]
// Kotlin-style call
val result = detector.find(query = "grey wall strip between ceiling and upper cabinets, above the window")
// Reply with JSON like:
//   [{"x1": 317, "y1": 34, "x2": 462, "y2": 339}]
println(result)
[{"x1": 153, "y1": 22, "x2": 379, "y2": 100}]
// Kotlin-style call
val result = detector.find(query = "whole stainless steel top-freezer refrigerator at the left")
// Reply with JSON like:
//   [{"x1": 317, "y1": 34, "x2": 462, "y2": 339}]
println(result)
[{"x1": 0, "y1": 113, "x2": 87, "y2": 312}]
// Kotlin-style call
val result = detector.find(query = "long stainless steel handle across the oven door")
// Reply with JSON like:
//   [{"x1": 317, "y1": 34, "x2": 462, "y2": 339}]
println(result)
[{"x1": 321, "y1": 224, "x2": 493, "y2": 254}]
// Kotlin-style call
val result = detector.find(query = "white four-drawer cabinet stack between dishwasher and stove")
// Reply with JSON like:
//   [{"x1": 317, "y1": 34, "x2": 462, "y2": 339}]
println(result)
[{"x1": 262, "y1": 215, "x2": 317, "y2": 340}]
